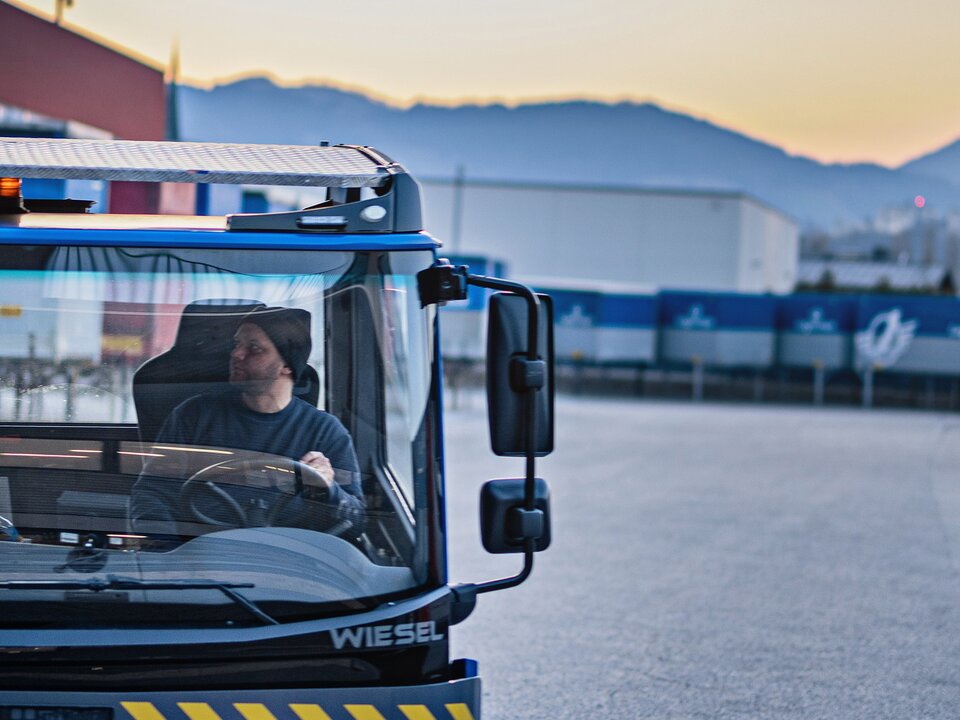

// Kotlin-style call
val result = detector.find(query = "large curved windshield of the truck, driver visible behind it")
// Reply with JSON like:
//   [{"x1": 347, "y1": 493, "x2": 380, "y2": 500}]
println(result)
[{"x1": 0, "y1": 246, "x2": 441, "y2": 627}]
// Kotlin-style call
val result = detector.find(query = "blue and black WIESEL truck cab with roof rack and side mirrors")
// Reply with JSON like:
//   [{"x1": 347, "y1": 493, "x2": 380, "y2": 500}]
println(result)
[{"x1": 0, "y1": 138, "x2": 553, "y2": 720}]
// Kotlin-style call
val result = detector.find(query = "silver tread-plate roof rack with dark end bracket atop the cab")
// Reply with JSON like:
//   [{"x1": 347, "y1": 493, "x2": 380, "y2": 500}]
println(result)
[{"x1": 0, "y1": 137, "x2": 422, "y2": 233}]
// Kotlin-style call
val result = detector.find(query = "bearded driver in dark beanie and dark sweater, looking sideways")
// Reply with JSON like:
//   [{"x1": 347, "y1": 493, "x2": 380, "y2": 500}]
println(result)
[{"x1": 131, "y1": 307, "x2": 364, "y2": 531}]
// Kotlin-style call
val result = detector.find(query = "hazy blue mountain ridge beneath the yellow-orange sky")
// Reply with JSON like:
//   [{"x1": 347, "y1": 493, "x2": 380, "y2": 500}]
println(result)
[{"x1": 180, "y1": 78, "x2": 960, "y2": 228}]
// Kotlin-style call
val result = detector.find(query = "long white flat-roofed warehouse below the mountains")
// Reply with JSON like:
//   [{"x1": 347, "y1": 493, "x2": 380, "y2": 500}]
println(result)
[{"x1": 421, "y1": 179, "x2": 799, "y2": 293}]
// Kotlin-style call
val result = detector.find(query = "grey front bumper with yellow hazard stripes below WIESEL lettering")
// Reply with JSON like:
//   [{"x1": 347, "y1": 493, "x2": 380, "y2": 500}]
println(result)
[{"x1": 0, "y1": 677, "x2": 480, "y2": 720}]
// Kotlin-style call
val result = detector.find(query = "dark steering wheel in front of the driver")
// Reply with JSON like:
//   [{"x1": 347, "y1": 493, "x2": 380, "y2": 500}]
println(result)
[{"x1": 180, "y1": 458, "x2": 333, "y2": 528}]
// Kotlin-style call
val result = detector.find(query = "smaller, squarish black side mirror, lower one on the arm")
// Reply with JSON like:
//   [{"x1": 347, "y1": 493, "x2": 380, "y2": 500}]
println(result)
[{"x1": 480, "y1": 478, "x2": 550, "y2": 553}]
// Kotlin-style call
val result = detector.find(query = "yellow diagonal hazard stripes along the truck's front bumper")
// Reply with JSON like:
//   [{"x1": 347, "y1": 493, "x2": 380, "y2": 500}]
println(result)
[{"x1": 120, "y1": 701, "x2": 475, "y2": 720}]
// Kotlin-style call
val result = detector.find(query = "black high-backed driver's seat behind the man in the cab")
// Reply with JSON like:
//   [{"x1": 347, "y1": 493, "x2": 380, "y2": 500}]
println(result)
[{"x1": 133, "y1": 300, "x2": 320, "y2": 442}]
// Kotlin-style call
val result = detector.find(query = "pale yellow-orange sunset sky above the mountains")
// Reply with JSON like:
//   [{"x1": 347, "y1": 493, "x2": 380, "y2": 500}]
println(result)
[{"x1": 13, "y1": 0, "x2": 960, "y2": 166}]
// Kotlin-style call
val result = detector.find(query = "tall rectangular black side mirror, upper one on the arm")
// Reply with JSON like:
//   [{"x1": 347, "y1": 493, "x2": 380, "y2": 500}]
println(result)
[{"x1": 487, "y1": 293, "x2": 554, "y2": 457}]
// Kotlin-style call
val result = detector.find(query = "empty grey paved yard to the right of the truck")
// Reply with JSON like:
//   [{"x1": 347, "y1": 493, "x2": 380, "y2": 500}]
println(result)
[{"x1": 445, "y1": 394, "x2": 960, "y2": 720}]
